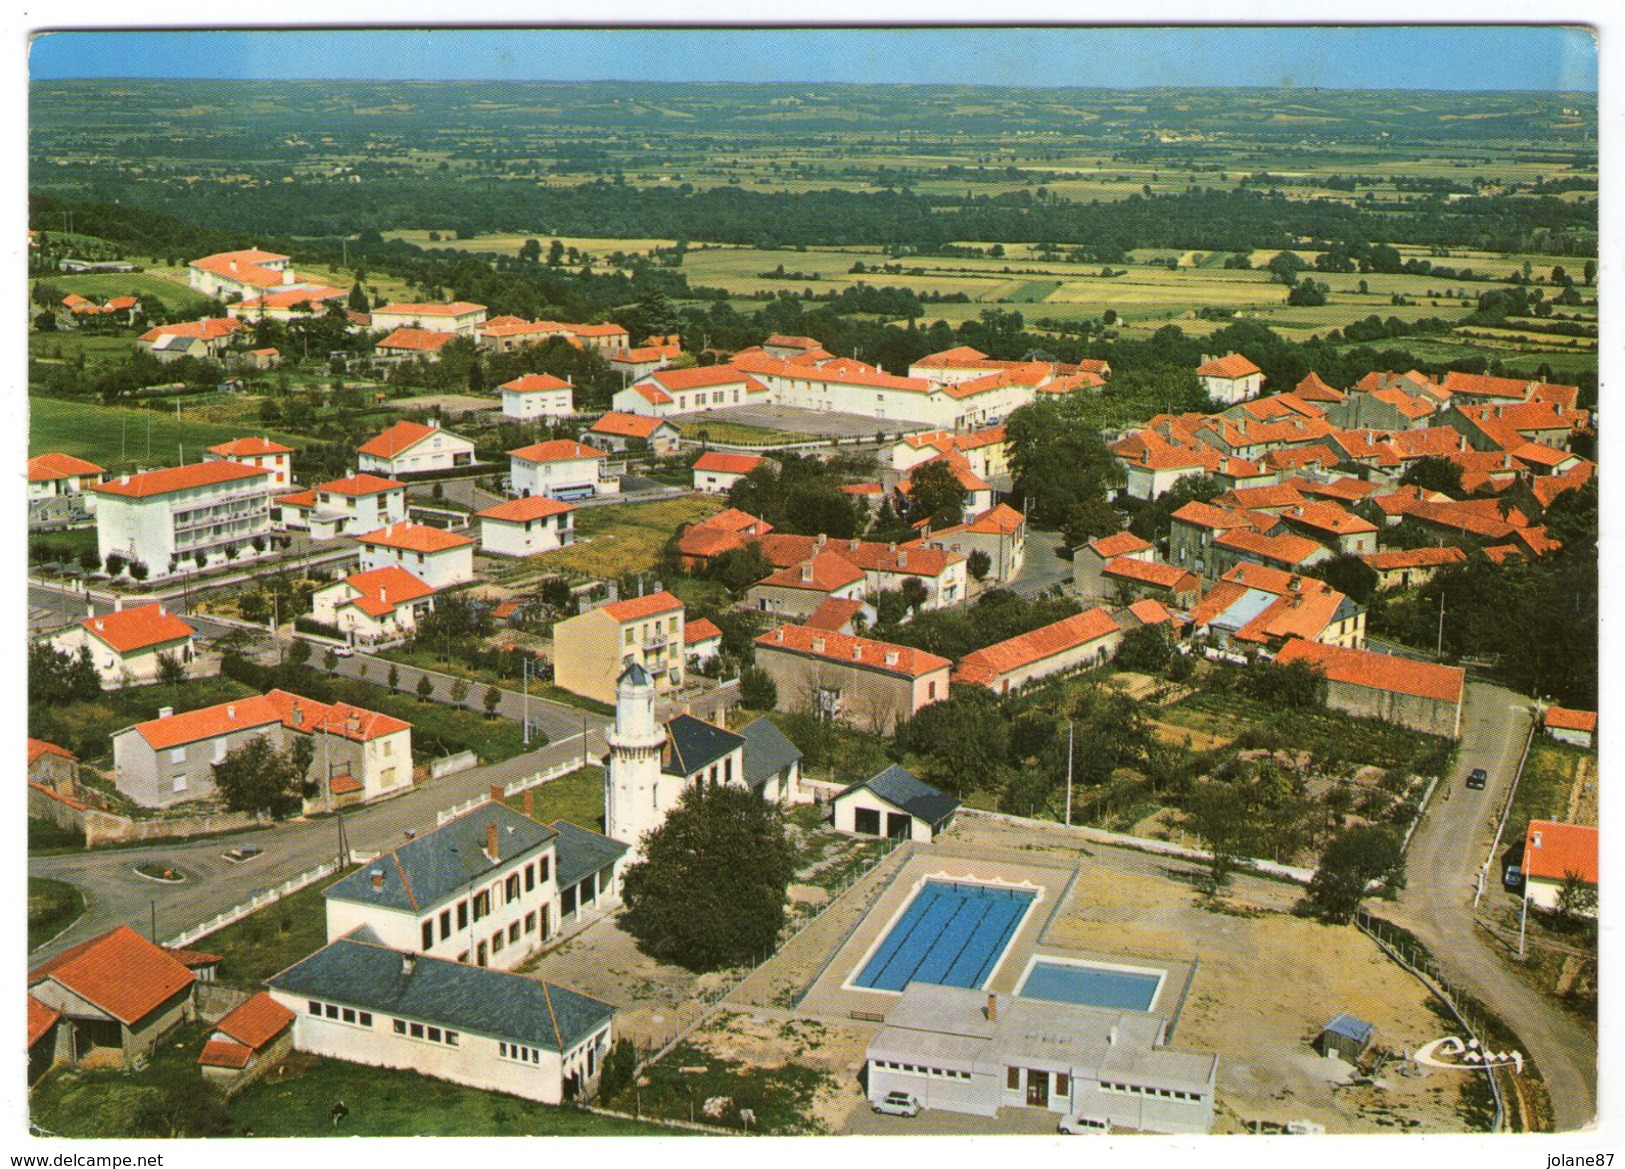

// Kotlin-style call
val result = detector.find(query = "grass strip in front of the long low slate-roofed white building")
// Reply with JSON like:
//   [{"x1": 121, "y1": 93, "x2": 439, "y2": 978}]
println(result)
[{"x1": 229, "y1": 1055, "x2": 678, "y2": 1136}]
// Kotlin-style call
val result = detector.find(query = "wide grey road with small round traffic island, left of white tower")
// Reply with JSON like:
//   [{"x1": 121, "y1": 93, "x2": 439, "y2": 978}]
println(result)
[{"x1": 28, "y1": 730, "x2": 605, "y2": 964}]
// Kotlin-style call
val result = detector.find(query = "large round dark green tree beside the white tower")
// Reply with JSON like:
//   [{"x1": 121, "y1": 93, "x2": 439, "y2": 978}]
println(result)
[{"x1": 621, "y1": 784, "x2": 796, "y2": 971}]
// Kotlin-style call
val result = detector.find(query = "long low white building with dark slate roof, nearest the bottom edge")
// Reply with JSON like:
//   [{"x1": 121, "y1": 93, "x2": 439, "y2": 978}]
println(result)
[{"x1": 267, "y1": 927, "x2": 616, "y2": 1104}]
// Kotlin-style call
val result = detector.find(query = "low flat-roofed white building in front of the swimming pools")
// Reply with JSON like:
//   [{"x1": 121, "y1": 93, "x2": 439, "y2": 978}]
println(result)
[{"x1": 868, "y1": 982, "x2": 1219, "y2": 1133}]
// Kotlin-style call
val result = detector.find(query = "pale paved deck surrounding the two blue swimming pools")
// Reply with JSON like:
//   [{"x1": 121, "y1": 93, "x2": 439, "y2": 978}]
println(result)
[{"x1": 796, "y1": 844, "x2": 1193, "y2": 1032}]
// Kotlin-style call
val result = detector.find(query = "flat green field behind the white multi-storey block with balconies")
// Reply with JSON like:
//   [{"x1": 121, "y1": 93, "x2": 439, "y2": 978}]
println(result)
[{"x1": 28, "y1": 397, "x2": 309, "y2": 472}]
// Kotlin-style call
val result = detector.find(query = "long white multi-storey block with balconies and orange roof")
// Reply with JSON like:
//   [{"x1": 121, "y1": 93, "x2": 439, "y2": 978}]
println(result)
[{"x1": 91, "y1": 458, "x2": 271, "y2": 577}]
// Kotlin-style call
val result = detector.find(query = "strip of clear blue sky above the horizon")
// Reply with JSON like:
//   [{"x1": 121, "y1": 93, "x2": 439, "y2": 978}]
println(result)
[{"x1": 29, "y1": 26, "x2": 1597, "y2": 91}]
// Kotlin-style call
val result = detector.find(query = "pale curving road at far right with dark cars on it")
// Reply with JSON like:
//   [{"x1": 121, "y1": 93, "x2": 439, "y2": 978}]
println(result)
[{"x1": 1394, "y1": 683, "x2": 1597, "y2": 1132}]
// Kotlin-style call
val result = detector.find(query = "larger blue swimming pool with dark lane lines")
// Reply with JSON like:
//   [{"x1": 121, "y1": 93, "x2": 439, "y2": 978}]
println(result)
[{"x1": 852, "y1": 881, "x2": 1037, "y2": 990}]
